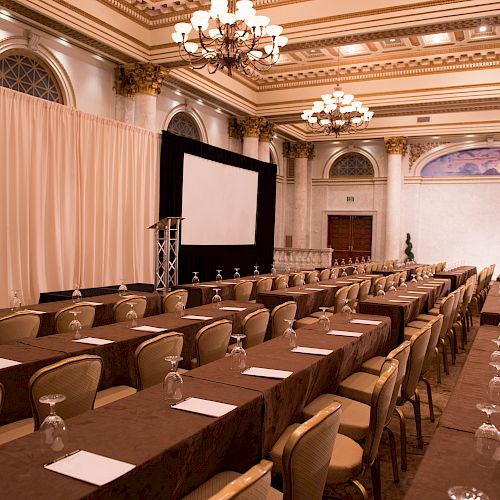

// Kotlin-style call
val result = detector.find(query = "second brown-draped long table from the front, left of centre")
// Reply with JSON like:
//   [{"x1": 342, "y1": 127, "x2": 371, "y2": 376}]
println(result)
[{"x1": 0, "y1": 301, "x2": 262, "y2": 424}]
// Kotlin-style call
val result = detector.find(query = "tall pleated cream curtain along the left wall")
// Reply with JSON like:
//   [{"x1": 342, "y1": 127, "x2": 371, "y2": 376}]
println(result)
[{"x1": 0, "y1": 87, "x2": 160, "y2": 307}]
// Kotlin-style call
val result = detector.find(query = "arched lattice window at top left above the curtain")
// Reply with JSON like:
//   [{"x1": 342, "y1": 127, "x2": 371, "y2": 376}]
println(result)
[{"x1": 0, "y1": 50, "x2": 64, "y2": 104}]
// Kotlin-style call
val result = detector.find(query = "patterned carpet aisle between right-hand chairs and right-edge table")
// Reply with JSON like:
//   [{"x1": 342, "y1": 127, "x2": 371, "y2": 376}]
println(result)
[{"x1": 352, "y1": 316, "x2": 479, "y2": 500}]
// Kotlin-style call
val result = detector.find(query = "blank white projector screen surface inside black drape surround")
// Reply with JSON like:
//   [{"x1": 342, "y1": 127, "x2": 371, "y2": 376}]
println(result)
[{"x1": 181, "y1": 154, "x2": 259, "y2": 245}]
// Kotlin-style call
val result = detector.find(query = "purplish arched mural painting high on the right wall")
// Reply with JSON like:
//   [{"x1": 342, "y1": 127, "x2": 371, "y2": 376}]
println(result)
[{"x1": 420, "y1": 148, "x2": 500, "y2": 177}]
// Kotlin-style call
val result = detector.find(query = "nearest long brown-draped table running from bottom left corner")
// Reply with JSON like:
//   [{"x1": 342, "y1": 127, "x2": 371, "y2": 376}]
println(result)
[{"x1": 0, "y1": 316, "x2": 390, "y2": 500}]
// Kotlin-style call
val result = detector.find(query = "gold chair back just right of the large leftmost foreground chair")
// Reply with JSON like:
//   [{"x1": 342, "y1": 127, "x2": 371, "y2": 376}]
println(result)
[{"x1": 134, "y1": 332, "x2": 184, "y2": 391}]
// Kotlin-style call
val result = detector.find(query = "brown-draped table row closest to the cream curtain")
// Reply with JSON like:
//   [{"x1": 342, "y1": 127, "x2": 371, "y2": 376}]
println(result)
[{"x1": 0, "y1": 292, "x2": 162, "y2": 337}]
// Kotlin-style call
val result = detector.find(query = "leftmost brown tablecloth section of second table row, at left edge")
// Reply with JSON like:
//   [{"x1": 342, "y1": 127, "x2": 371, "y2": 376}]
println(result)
[{"x1": 0, "y1": 343, "x2": 67, "y2": 425}]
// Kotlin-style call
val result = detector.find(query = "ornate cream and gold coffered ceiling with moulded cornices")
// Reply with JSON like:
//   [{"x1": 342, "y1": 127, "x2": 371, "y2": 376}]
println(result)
[{"x1": 0, "y1": 0, "x2": 500, "y2": 140}]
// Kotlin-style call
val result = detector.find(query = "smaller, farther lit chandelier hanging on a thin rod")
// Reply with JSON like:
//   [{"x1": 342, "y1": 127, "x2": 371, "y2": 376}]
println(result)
[{"x1": 301, "y1": 49, "x2": 373, "y2": 137}]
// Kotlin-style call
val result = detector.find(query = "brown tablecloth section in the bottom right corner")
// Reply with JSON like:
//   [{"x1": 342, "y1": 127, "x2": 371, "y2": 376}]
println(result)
[{"x1": 405, "y1": 428, "x2": 500, "y2": 500}]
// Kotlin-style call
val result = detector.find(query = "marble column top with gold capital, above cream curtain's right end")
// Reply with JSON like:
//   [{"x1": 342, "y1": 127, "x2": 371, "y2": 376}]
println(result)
[{"x1": 115, "y1": 63, "x2": 167, "y2": 131}]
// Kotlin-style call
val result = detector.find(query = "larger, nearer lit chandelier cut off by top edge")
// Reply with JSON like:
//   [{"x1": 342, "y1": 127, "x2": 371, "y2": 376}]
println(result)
[{"x1": 172, "y1": 0, "x2": 288, "y2": 76}]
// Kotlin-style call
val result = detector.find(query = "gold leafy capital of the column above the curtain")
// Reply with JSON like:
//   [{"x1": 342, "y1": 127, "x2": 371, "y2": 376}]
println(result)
[{"x1": 115, "y1": 63, "x2": 167, "y2": 97}]
